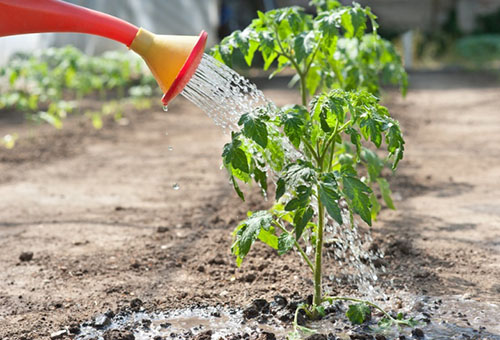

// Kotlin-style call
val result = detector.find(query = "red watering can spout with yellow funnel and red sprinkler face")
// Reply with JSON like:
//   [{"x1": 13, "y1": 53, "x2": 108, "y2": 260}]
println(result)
[{"x1": 0, "y1": 0, "x2": 207, "y2": 105}]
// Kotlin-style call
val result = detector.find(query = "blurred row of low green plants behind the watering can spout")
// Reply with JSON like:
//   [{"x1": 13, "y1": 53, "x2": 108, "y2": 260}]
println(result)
[{"x1": 0, "y1": 46, "x2": 156, "y2": 147}]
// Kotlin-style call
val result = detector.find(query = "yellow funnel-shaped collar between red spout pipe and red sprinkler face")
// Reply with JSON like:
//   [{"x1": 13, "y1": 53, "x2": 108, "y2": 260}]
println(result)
[{"x1": 129, "y1": 28, "x2": 198, "y2": 93}]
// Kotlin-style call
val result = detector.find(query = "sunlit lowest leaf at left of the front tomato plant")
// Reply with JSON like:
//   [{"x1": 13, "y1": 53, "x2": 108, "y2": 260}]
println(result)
[{"x1": 231, "y1": 210, "x2": 273, "y2": 266}]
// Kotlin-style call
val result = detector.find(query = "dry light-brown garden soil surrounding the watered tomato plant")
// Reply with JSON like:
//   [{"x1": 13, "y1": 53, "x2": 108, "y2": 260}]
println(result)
[{"x1": 0, "y1": 72, "x2": 500, "y2": 339}]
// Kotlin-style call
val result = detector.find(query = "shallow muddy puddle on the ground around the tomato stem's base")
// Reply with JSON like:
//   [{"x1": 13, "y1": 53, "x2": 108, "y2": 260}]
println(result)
[{"x1": 76, "y1": 296, "x2": 500, "y2": 340}]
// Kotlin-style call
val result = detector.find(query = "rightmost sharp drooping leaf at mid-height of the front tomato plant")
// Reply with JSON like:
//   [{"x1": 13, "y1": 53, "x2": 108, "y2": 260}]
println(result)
[{"x1": 342, "y1": 176, "x2": 372, "y2": 225}]
